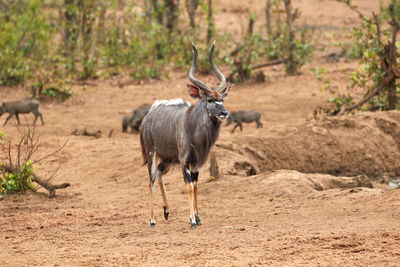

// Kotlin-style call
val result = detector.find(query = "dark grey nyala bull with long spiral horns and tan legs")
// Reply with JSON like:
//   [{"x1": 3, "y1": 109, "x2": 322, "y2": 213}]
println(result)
[{"x1": 140, "y1": 41, "x2": 232, "y2": 228}]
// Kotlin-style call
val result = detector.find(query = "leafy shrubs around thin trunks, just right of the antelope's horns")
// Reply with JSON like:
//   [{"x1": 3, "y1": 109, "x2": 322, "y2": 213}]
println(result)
[{"x1": 225, "y1": 0, "x2": 315, "y2": 82}]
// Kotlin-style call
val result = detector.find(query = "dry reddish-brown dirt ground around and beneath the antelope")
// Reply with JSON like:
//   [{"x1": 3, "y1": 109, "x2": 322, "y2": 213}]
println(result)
[{"x1": 0, "y1": 0, "x2": 400, "y2": 266}]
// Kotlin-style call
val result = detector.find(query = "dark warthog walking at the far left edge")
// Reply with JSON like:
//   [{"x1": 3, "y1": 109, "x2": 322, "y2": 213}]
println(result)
[{"x1": 0, "y1": 99, "x2": 44, "y2": 125}]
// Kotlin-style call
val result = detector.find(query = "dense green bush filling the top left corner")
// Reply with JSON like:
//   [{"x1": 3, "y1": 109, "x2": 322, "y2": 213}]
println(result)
[{"x1": 0, "y1": 0, "x2": 51, "y2": 85}]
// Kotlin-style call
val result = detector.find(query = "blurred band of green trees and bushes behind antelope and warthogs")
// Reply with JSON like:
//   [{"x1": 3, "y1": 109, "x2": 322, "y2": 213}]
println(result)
[{"x1": 0, "y1": 0, "x2": 313, "y2": 100}]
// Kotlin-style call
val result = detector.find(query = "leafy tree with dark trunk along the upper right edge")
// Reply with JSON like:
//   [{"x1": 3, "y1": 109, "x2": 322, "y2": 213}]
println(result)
[{"x1": 326, "y1": 0, "x2": 400, "y2": 114}]
